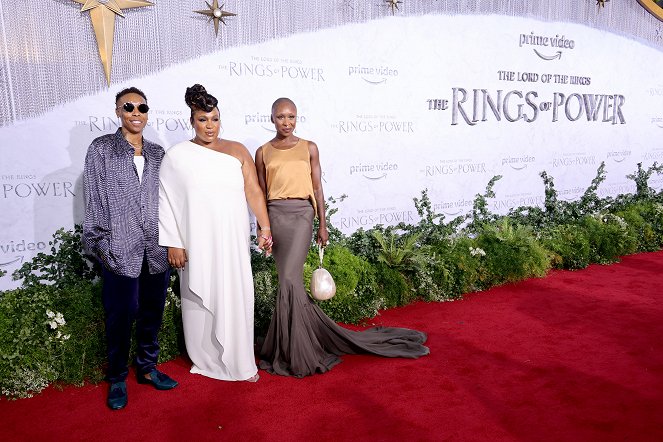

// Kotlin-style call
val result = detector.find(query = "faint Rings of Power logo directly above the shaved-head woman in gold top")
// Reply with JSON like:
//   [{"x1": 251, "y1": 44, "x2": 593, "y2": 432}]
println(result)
[{"x1": 219, "y1": 56, "x2": 325, "y2": 83}]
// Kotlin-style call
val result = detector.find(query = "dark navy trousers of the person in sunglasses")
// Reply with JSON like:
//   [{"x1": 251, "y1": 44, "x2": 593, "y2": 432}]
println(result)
[{"x1": 102, "y1": 259, "x2": 170, "y2": 383}]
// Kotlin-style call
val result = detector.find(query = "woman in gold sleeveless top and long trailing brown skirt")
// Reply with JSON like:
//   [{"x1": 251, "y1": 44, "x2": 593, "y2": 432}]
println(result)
[{"x1": 255, "y1": 98, "x2": 429, "y2": 377}]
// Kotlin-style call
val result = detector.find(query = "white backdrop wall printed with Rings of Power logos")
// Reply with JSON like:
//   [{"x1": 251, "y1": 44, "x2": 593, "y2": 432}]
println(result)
[{"x1": 0, "y1": 1, "x2": 663, "y2": 289}]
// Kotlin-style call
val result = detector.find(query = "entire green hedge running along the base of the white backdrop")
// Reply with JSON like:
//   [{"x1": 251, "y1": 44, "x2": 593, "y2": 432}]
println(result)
[{"x1": 0, "y1": 163, "x2": 663, "y2": 398}]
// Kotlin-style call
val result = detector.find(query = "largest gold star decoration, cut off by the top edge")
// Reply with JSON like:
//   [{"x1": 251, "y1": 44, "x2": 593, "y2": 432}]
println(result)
[{"x1": 73, "y1": 0, "x2": 152, "y2": 85}]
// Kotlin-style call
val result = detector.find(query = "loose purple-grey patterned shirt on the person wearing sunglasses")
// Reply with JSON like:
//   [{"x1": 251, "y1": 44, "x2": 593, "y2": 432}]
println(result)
[{"x1": 83, "y1": 129, "x2": 169, "y2": 278}]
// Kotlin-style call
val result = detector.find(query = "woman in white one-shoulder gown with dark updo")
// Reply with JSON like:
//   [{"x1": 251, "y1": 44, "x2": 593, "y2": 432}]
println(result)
[{"x1": 159, "y1": 85, "x2": 271, "y2": 382}]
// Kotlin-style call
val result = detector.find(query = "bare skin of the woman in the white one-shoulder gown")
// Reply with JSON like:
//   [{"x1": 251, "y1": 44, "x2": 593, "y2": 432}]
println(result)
[{"x1": 168, "y1": 108, "x2": 272, "y2": 269}]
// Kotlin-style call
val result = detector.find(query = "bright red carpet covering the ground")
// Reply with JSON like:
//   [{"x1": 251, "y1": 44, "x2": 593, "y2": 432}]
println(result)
[{"x1": 0, "y1": 252, "x2": 663, "y2": 442}]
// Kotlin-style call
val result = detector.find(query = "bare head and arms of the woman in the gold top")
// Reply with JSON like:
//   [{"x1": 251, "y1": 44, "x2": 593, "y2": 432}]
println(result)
[{"x1": 255, "y1": 100, "x2": 329, "y2": 246}]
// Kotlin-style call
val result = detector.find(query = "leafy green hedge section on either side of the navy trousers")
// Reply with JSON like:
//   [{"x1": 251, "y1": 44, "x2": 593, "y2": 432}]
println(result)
[{"x1": 0, "y1": 226, "x2": 183, "y2": 398}]
